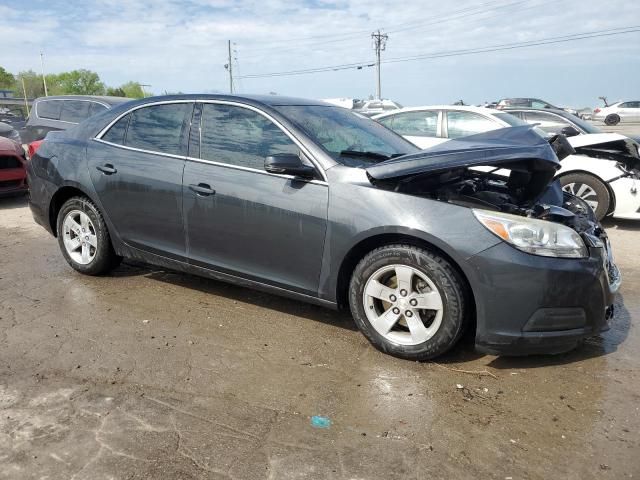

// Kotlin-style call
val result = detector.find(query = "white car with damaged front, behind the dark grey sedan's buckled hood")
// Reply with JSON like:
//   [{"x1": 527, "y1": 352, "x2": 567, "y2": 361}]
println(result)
[{"x1": 373, "y1": 105, "x2": 640, "y2": 220}]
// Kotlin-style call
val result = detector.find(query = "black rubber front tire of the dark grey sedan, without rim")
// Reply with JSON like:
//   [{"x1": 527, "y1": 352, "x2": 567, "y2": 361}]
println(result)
[{"x1": 349, "y1": 245, "x2": 466, "y2": 360}]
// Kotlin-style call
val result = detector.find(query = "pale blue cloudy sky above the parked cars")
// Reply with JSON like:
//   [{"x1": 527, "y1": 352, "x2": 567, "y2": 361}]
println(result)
[{"x1": 0, "y1": 0, "x2": 640, "y2": 108}]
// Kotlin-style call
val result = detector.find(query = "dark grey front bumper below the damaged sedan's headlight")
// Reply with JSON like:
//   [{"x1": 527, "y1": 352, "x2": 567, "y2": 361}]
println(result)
[{"x1": 469, "y1": 243, "x2": 620, "y2": 355}]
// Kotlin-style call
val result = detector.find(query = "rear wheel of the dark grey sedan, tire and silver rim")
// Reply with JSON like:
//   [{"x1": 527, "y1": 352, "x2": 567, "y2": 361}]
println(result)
[{"x1": 57, "y1": 197, "x2": 121, "y2": 275}]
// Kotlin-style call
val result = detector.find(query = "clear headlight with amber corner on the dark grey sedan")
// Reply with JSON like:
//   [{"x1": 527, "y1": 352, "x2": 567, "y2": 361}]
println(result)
[{"x1": 473, "y1": 209, "x2": 588, "y2": 258}]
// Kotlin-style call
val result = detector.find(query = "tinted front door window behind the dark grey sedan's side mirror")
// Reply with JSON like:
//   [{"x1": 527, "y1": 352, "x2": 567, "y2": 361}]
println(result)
[{"x1": 200, "y1": 103, "x2": 299, "y2": 170}]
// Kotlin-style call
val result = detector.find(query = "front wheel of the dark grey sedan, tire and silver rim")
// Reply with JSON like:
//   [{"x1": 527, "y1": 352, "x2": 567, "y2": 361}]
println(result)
[{"x1": 349, "y1": 245, "x2": 465, "y2": 360}]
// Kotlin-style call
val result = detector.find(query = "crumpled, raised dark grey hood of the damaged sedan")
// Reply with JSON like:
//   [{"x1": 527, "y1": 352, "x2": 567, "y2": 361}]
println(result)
[{"x1": 366, "y1": 125, "x2": 560, "y2": 180}]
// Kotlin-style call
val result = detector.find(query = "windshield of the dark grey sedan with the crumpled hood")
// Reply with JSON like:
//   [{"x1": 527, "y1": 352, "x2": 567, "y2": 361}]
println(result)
[{"x1": 275, "y1": 105, "x2": 418, "y2": 167}]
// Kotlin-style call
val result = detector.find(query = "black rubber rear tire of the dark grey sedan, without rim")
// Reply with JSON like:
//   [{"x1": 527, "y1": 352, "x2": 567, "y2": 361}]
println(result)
[{"x1": 56, "y1": 197, "x2": 122, "y2": 275}]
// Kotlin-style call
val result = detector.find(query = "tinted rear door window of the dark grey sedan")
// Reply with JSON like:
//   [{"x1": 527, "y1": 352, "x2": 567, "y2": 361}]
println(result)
[{"x1": 125, "y1": 103, "x2": 193, "y2": 155}]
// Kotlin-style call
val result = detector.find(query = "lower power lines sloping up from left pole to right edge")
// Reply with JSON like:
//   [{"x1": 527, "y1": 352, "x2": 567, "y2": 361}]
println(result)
[{"x1": 242, "y1": 25, "x2": 640, "y2": 78}]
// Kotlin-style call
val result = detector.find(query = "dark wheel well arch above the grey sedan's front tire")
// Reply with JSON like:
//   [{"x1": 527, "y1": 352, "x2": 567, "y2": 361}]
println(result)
[{"x1": 336, "y1": 233, "x2": 476, "y2": 320}]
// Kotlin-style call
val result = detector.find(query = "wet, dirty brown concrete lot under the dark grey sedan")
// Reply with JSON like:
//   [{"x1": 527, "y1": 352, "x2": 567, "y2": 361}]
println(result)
[{"x1": 0, "y1": 193, "x2": 640, "y2": 480}]
